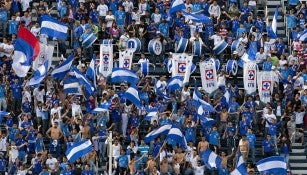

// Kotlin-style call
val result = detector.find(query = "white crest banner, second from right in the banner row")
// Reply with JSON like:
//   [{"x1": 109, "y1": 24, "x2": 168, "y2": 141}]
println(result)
[{"x1": 243, "y1": 62, "x2": 257, "y2": 94}]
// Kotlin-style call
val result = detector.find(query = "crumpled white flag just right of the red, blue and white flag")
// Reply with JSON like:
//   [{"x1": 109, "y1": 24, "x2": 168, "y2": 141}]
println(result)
[{"x1": 32, "y1": 43, "x2": 54, "y2": 70}]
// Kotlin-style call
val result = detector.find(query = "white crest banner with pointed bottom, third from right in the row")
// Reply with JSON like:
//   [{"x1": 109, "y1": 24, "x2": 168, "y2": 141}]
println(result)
[{"x1": 199, "y1": 61, "x2": 218, "y2": 94}]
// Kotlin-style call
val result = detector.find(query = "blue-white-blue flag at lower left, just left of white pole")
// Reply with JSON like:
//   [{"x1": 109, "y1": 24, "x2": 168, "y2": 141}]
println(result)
[{"x1": 65, "y1": 140, "x2": 93, "y2": 163}]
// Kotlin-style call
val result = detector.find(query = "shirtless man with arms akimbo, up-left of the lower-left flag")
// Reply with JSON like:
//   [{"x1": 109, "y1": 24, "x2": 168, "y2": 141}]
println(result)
[{"x1": 46, "y1": 122, "x2": 63, "y2": 155}]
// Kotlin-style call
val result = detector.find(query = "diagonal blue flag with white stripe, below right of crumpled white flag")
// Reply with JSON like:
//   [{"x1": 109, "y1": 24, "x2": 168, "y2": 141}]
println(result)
[{"x1": 51, "y1": 54, "x2": 74, "y2": 80}]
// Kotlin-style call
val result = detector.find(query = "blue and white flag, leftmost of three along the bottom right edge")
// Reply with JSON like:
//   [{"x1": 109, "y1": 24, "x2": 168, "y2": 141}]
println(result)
[{"x1": 200, "y1": 149, "x2": 222, "y2": 169}]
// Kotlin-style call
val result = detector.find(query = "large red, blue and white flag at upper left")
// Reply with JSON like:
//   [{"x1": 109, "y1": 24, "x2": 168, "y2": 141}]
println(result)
[{"x1": 12, "y1": 26, "x2": 40, "y2": 77}]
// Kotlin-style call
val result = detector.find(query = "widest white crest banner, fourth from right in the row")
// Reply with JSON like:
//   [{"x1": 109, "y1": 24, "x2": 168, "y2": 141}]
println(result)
[{"x1": 171, "y1": 53, "x2": 193, "y2": 84}]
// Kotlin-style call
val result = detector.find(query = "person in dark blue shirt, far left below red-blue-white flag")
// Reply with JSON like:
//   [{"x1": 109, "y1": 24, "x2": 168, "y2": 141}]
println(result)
[{"x1": 11, "y1": 78, "x2": 22, "y2": 114}]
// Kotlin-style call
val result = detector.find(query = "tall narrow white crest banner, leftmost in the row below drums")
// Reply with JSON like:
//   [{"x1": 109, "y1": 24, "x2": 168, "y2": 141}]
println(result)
[{"x1": 99, "y1": 43, "x2": 113, "y2": 77}]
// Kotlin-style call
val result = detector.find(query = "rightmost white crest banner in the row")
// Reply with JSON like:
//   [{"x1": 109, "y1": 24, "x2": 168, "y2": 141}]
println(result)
[{"x1": 258, "y1": 71, "x2": 274, "y2": 103}]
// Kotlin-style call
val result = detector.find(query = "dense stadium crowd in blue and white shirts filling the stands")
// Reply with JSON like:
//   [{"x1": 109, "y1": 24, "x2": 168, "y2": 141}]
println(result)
[{"x1": 0, "y1": 0, "x2": 307, "y2": 175}]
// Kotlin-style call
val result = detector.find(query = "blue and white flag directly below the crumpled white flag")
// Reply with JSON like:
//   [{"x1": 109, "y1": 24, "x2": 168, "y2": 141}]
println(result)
[{"x1": 26, "y1": 60, "x2": 49, "y2": 86}]
